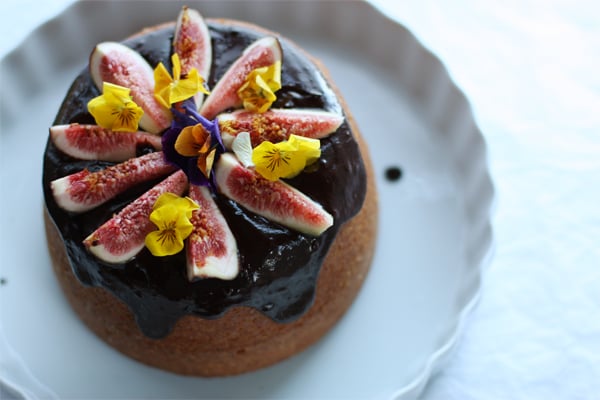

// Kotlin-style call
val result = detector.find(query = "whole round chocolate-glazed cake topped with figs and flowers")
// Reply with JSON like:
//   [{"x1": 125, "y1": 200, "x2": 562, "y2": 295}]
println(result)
[{"x1": 43, "y1": 7, "x2": 377, "y2": 376}]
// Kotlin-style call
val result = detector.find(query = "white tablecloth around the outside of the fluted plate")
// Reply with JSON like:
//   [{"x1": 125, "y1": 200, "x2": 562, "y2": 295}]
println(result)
[{"x1": 0, "y1": 0, "x2": 600, "y2": 399}]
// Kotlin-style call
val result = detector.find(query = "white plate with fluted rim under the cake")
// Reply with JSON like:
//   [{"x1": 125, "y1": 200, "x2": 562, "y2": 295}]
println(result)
[{"x1": 0, "y1": 1, "x2": 493, "y2": 398}]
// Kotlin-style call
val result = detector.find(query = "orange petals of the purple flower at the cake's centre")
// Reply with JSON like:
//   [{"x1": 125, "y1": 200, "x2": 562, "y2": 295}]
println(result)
[{"x1": 175, "y1": 124, "x2": 217, "y2": 178}]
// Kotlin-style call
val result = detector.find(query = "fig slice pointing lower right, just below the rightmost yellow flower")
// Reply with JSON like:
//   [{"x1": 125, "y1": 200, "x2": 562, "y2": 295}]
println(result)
[{"x1": 215, "y1": 153, "x2": 333, "y2": 236}]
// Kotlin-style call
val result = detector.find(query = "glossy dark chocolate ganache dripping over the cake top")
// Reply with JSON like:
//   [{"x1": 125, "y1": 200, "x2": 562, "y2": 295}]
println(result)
[{"x1": 43, "y1": 22, "x2": 366, "y2": 338}]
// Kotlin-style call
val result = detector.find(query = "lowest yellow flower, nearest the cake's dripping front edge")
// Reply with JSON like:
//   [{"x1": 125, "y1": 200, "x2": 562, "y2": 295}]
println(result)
[{"x1": 145, "y1": 193, "x2": 200, "y2": 257}]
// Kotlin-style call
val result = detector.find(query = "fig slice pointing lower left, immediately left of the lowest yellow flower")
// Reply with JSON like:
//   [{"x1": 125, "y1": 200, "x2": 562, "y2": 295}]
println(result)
[{"x1": 83, "y1": 171, "x2": 188, "y2": 264}]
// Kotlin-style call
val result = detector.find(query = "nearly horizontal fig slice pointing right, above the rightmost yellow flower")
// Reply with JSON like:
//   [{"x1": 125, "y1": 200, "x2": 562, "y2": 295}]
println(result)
[{"x1": 217, "y1": 109, "x2": 344, "y2": 149}]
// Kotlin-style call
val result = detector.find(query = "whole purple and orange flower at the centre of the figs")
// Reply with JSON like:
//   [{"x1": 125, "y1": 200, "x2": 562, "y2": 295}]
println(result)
[{"x1": 161, "y1": 99, "x2": 225, "y2": 189}]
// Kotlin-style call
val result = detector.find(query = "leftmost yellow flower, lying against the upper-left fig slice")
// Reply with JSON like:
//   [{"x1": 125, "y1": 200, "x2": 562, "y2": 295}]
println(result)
[{"x1": 88, "y1": 82, "x2": 144, "y2": 132}]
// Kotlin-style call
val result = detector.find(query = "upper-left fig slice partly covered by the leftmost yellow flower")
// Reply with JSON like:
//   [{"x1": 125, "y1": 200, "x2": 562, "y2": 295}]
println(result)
[{"x1": 90, "y1": 42, "x2": 172, "y2": 133}]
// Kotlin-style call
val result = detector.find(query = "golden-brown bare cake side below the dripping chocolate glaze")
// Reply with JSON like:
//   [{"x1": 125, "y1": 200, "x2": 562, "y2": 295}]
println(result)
[{"x1": 44, "y1": 19, "x2": 378, "y2": 376}]
